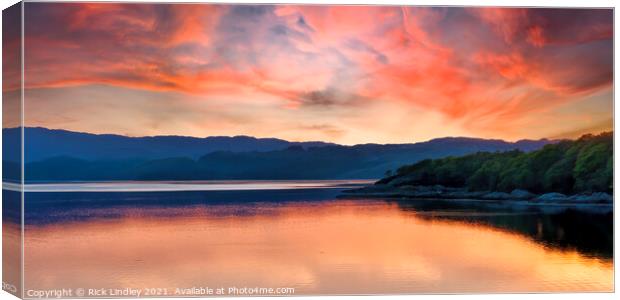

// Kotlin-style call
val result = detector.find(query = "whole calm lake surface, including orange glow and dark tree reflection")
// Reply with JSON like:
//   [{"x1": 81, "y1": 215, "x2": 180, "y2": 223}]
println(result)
[{"x1": 15, "y1": 182, "x2": 613, "y2": 295}]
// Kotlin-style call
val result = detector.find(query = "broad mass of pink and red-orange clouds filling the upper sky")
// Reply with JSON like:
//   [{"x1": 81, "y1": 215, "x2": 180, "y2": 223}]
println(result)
[{"x1": 17, "y1": 3, "x2": 613, "y2": 142}]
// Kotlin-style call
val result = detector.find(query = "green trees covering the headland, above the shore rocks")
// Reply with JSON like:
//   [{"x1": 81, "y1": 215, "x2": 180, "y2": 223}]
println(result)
[{"x1": 379, "y1": 132, "x2": 613, "y2": 194}]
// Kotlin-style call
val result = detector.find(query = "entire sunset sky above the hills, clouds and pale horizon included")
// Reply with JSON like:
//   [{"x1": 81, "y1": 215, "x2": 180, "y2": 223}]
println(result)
[{"x1": 10, "y1": 3, "x2": 613, "y2": 144}]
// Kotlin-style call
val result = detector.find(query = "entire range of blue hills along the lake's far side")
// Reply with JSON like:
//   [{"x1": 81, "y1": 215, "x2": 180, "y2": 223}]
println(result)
[{"x1": 10, "y1": 128, "x2": 554, "y2": 181}]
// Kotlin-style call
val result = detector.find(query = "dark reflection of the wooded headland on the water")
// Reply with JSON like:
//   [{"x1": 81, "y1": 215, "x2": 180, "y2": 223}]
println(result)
[{"x1": 394, "y1": 200, "x2": 613, "y2": 258}]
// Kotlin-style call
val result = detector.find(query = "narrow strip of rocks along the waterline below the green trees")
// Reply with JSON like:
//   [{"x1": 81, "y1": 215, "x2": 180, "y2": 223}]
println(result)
[{"x1": 343, "y1": 184, "x2": 613, "y2": 204}]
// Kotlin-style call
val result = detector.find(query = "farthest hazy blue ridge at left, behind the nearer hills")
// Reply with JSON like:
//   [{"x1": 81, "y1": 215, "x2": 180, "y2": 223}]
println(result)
[{"x1": 2, "y1": 127, "x2": 329, "y2": 163}]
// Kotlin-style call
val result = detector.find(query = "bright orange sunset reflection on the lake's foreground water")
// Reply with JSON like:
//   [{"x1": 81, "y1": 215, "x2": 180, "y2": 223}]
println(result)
[{"x1": 25, "y1": 201, "x2": 613, "y2": 294}]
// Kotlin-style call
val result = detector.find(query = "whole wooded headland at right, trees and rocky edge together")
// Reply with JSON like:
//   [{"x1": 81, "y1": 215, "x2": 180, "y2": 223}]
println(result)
[{"x1": 343, "y1": 132, "x2": 614, "y2": 214}]
